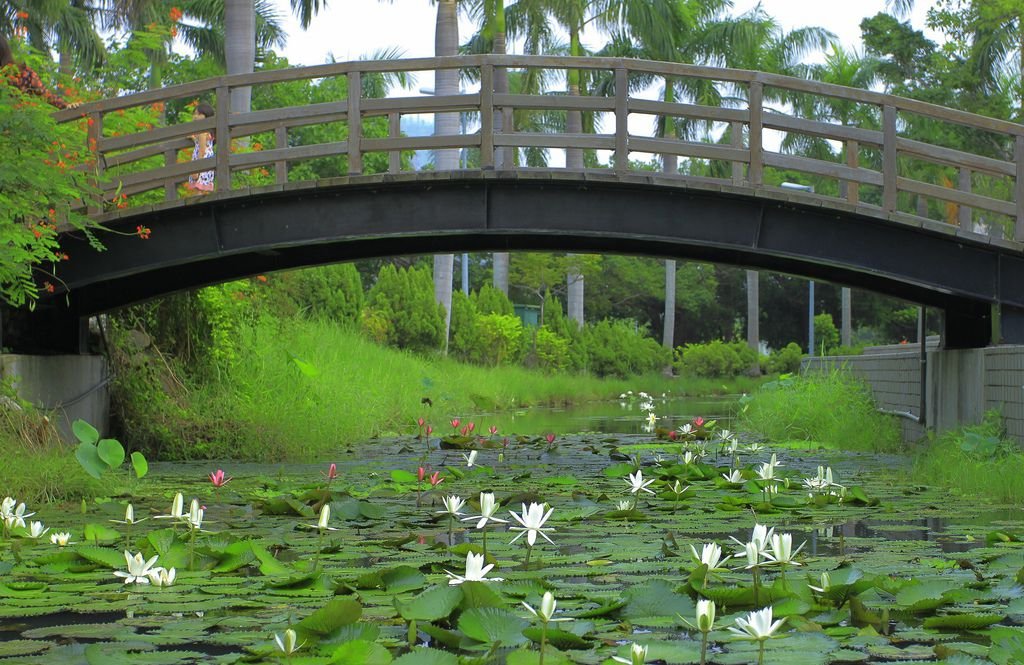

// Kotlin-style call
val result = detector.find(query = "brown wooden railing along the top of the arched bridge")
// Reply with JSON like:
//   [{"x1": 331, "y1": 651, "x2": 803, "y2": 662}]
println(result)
[{"x1": 57, "y1": 55, "x2": 1024, "y2": 242}]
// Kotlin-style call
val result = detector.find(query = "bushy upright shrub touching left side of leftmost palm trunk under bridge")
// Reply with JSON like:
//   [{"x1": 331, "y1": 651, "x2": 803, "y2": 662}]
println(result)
[{"x1": 361, "y1": 264, "x2": 444, "y2": 351}]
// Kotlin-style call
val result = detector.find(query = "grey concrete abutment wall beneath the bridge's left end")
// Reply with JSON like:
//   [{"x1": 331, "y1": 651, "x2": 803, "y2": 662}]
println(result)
[{"x1": 0, "y1": 354, "x2": 110, "y2": 442}]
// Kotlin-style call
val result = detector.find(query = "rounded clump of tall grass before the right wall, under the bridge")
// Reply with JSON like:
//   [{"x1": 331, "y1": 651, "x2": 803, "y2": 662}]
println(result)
[{"x1": 737, "y1": 370, "x2": 901, "y2": 451}]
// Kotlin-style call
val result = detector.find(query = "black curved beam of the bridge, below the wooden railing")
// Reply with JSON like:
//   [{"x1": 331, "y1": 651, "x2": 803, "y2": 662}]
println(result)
[{"x1": 37, "y1": 169, "x2": 1024, "y2": 348}]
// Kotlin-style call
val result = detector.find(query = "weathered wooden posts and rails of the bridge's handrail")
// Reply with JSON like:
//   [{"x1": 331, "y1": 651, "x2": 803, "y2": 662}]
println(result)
[{"x1": 54, "y1": 54, "x2": 1024, "y2": 242}]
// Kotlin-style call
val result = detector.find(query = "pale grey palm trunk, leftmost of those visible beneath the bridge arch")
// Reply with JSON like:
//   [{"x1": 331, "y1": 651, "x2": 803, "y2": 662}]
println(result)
[{"x1": 434, "y1": 0, "x2": 459, "y2": 354}]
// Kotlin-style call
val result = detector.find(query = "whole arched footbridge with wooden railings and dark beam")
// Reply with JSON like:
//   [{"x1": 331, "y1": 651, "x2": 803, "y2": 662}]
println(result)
[{"x1": 25, "y1": 55, "x2": 1024, "y2": 346}]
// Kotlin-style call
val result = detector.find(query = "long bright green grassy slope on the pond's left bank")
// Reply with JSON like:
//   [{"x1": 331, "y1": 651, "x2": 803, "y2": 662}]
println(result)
[{"x1": 184, "y1": 320, "x2": 757, "y2": 461}]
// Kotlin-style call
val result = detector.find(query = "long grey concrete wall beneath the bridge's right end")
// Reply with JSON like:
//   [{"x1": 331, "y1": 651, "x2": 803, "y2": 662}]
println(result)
[{"x1": 802, "y1": 340, "x2": 1024, "y2": 444}]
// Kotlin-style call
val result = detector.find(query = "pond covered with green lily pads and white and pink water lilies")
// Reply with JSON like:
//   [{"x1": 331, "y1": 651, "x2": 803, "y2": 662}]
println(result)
[{"x1": 0, "y1": 411, "x2": 1024, "y2": 665}]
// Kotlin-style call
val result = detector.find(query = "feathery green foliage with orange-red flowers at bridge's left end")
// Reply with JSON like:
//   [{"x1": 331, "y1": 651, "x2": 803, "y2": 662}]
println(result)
[{"x1": 0, "y1": 66, "x2": 100, "y2": 305}]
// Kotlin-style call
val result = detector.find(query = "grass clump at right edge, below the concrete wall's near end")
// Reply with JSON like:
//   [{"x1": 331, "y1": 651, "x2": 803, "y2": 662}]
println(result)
[{"x1": 910, "y1": 412, "x2": 1024, "y2": 503}]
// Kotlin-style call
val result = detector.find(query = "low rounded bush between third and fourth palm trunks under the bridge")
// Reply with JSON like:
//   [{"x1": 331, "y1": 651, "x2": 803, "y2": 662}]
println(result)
[{"x1": 583, "y1": 320, "x2": 672, "y2": 378}]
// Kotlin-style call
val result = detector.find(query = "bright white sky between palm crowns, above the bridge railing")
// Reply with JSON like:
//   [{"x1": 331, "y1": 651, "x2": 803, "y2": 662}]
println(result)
[{"x1": 273, "y1": 0, "x2": 935, "y2": 67}]
